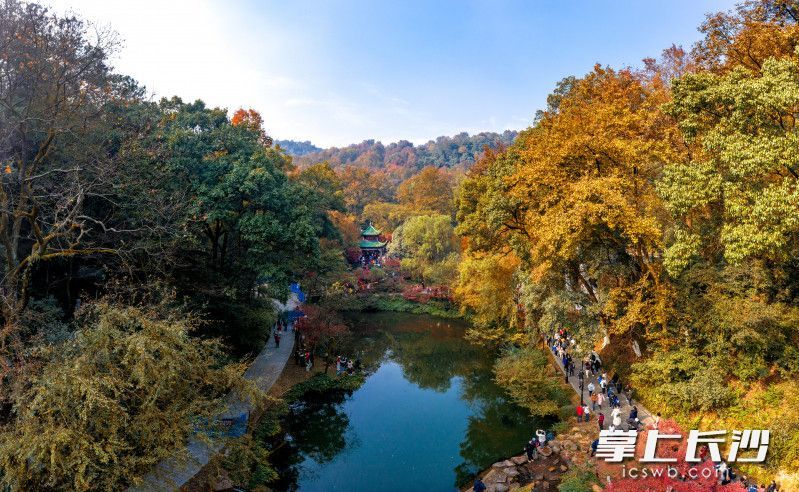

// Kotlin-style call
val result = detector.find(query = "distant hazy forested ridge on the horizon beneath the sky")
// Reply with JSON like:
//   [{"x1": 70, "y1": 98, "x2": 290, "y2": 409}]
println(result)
[{"x1": 277, "y1": 130, "x2": 518, "y2": 169}]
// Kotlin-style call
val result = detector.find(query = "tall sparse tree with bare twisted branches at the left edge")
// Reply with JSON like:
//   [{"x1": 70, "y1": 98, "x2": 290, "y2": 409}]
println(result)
[{"x1": 0, "y1": 2, "x2": 119, "y2": 326}]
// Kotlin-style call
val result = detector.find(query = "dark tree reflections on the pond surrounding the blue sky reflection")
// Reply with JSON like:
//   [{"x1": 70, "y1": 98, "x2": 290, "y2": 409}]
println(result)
[{"x1": 274, "y1": 313, "x2": 538, "y2": 490}]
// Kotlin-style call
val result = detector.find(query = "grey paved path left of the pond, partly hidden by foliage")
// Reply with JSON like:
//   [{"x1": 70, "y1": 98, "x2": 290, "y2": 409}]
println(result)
[{"x1": 128, "y1": 294, "x2": 299, "y2": 492}]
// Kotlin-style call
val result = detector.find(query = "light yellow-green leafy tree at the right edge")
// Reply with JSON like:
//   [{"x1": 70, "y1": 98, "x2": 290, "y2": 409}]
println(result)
[{"x1": 659, "y1": 58, "x2": 799, "y2": 273}]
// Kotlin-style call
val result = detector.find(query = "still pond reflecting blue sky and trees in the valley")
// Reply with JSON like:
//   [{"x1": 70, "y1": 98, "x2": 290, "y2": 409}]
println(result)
[{"x1": 273, "y1": 313, "x2": 545, "y2": 492}]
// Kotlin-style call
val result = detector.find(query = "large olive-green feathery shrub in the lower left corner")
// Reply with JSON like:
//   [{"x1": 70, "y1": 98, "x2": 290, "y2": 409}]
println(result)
[{"x1": 0, "y1": 303, "x2": 248, "y2": 490}]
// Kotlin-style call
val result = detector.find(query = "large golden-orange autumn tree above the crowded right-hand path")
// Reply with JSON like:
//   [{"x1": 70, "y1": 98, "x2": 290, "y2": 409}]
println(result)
[{"x1": 458, "y1": 67, "x2": 675, "y2": 346}]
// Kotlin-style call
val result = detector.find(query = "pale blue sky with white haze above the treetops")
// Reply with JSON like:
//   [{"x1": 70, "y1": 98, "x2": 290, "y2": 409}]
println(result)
[{"x1": 50, "y1": 0, "x2": 734, "y2": 147}]
